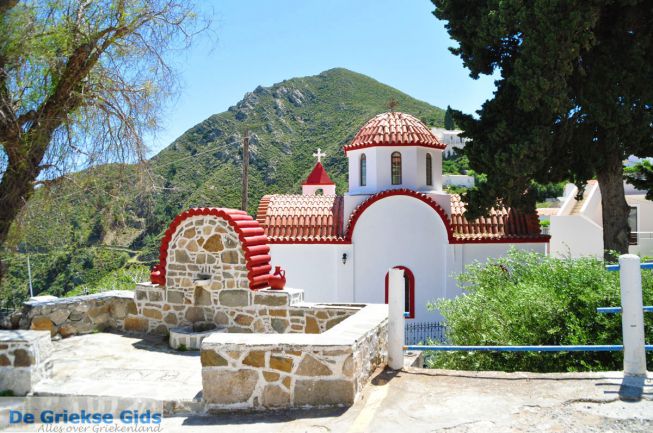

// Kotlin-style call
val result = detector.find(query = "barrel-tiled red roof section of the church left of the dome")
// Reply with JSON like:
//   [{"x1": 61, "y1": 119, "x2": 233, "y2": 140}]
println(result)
[{"x1": 256, "y1": 195, "x2": 344, "y2": 243}]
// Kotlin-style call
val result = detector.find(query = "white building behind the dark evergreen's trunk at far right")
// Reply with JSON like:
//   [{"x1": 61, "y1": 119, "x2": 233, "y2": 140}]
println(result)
[{"x1": 549, "y1": 180, "x2": 653, "y2": 257}]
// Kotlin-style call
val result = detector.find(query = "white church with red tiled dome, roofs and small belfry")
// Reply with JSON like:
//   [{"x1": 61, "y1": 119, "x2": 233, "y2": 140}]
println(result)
[{"x1": 257, "y1": 112, "x2": 549, "y2": 321}]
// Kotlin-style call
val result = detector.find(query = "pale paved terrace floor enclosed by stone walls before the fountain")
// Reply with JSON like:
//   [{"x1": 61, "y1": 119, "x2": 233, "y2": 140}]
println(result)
[{"x1": 34, "y1": 333, "x2": 202, "y2": 410}]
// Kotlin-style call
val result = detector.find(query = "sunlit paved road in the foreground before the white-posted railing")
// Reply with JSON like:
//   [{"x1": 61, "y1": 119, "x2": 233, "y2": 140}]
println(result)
[{"x1": 164, "y1": 368, "x2": 653, "y2": 433}]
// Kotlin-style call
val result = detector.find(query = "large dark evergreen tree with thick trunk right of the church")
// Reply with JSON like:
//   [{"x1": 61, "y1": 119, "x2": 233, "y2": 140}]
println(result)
[{"x1": 433, "y1": 0, "x2": 653, "y2": 257}]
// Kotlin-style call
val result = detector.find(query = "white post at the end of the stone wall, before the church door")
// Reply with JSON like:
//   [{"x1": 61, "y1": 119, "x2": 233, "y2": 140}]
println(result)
[{"x1": 388, "y1": 269, "x2": 405, "y2": 370}]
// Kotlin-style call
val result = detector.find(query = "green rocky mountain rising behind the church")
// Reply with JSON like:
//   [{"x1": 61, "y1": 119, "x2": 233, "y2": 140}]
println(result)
[{"x1": 0, "y1": 68, "x2": 444, "y2": 307}]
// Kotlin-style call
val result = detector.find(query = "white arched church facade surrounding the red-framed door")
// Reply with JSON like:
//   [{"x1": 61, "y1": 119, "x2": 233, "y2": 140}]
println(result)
[{"x1": 352, "y1": 196, "x2": 450, "y2": 321}]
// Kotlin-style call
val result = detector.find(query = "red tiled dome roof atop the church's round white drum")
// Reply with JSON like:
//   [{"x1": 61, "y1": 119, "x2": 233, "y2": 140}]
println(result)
[{"x1": 345, "y1": 111, "x2": 446, "y2": 153}]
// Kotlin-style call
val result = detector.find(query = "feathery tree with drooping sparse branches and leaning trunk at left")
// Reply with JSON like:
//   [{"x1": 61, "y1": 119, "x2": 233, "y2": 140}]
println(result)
[{"x1": 0, "y1": 0, "x2": 206, "y2": 253}]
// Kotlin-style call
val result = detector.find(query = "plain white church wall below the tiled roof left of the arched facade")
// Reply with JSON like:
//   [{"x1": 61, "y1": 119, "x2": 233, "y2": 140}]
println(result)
[{"x1": 270, "y1": 244, "x2": 354, "y2": 302}]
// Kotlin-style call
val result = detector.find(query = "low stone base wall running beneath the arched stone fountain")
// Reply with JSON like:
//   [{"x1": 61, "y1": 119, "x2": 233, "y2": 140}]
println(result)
[{"x1": 125, "y1": 281, "x2": 362, "y2": 334}]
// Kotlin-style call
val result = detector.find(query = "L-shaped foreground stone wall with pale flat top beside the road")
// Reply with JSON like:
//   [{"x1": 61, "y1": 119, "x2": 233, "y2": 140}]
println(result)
[{"x1": 201, "y1": 305, "x2": 388, "y2": 411}]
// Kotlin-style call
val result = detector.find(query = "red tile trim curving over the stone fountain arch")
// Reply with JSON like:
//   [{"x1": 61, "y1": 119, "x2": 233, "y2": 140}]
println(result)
[{"x1": 151, "y1": 207, "x2": 272, "y2": 290}]
